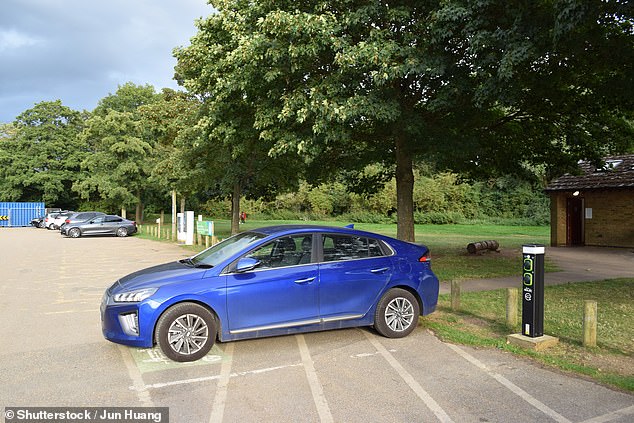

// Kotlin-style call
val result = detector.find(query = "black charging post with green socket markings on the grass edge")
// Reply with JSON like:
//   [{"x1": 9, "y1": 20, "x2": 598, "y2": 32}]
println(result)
[{"x1": 522, "y1": 244, "x2": 546, "y2": 338}]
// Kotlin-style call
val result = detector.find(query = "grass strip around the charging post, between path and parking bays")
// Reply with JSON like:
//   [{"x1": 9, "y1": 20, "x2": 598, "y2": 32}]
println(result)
[{"x1": 421, "y1": 279, "x2": 634, "y2": 391}]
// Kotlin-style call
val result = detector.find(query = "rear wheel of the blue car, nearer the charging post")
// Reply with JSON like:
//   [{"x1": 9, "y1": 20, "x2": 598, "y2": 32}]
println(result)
[{"x1": 374, "y1": 288, "x2": 420, "y2": 338}]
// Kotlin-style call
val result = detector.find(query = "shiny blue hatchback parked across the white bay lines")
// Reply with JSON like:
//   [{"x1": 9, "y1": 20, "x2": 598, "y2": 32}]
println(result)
[{"x1": 101, "y1": 225, "x2": 438, "y2": 361}]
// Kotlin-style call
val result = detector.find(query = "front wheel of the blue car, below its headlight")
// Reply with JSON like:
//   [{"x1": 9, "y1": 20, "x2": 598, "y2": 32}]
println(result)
[{"x1": 156, "y1": 303, "x2": 218, "y2": 362}]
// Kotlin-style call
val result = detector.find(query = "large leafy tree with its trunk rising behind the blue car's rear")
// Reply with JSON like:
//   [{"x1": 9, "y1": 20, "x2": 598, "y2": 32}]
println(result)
[{"x1": 179, "y1": 0, "x2": 634, "y2": 240}]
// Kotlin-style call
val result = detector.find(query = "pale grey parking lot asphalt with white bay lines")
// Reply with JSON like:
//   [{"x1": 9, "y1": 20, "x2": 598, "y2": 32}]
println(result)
[{"x1": 0, "y1": 228, "x2": 634, "y2": 423}]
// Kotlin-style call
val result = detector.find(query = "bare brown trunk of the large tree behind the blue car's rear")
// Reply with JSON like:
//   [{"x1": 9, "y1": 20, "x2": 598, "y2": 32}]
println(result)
[{"x1": 396, "y1": 135, "x2": 415, "y2": 242}]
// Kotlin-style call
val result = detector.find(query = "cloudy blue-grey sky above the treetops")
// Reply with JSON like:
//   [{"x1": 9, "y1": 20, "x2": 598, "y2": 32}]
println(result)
[{"x1": 0, "y1": 0, "x2": 213, "y2": 123}]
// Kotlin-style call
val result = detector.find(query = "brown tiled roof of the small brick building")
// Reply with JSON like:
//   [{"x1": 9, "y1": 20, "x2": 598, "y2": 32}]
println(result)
[{"x1": 546, "y1": 154, "x2": 634, "y2": 191}]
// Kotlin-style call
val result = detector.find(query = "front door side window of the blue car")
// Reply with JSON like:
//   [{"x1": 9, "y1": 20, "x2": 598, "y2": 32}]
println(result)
[{"x1": 245, "y1": 234, "x2": 313, "y2": 269}]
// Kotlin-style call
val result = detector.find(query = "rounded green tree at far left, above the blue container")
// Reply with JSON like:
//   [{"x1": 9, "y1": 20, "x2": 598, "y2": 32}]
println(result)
[{"x1": 0, "y1": 100, "x2": 87, "y2": 208}]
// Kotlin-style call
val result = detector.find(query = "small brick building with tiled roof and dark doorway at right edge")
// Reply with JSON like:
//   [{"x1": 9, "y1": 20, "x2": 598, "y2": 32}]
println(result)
[{"x1": 546, "y1": 154, "x2": 634, "y2": 247}]
